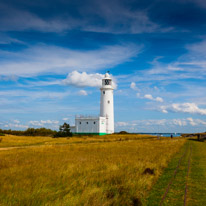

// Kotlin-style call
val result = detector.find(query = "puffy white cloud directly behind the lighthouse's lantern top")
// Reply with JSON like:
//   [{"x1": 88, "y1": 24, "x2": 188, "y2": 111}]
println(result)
[{"x1": 62, "y1": 71, "x2": 117, "y2": 88}]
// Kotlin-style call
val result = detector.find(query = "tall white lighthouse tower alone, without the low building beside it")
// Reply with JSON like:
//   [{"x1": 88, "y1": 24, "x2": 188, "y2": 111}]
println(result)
[{"x1": 100, "y1": 73, "x2": 114, "y2": 134}]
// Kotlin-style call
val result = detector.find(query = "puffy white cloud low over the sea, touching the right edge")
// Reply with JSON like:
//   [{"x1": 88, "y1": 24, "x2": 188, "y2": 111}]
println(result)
[{"x1": 160, "y1": 103, "x2": 206, "y2": 115}]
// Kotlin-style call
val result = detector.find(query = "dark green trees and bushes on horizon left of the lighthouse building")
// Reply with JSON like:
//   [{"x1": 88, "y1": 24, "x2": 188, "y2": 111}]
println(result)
[{"x1": 0, "y1": 123, "x2": 72, "y2": 138}]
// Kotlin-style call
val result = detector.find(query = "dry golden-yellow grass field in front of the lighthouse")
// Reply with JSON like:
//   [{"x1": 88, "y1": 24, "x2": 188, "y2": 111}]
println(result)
[{"x1": 0, "y1": 135, "x2": 185, "y2": 206}]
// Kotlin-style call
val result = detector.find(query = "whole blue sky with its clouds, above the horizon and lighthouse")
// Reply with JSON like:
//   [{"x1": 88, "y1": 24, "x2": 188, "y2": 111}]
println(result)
[{"x1": 0, "y1": 0, "x2": 206, "y2": 132}]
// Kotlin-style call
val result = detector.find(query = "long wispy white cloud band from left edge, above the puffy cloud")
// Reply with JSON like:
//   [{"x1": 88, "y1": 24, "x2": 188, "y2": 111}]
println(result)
[{"x1": 0, "y1": 45, "x2": 142, "y2": 77}]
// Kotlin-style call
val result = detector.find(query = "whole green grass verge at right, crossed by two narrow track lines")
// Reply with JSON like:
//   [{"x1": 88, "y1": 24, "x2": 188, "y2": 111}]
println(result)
[{"x1": 146, "y1": 140, "x2": 206, "y2": 206}]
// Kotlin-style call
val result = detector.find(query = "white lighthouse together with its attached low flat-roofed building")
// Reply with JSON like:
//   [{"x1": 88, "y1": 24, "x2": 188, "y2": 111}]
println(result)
[{"x1": 71, "y1": 73, "x2": 114, "y2": 135}]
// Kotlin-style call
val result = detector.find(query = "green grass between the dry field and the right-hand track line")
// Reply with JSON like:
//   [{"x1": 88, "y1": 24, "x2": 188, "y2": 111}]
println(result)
[{"x1": 146, "y1": 141, "x2": 189, "y2": 206}]
